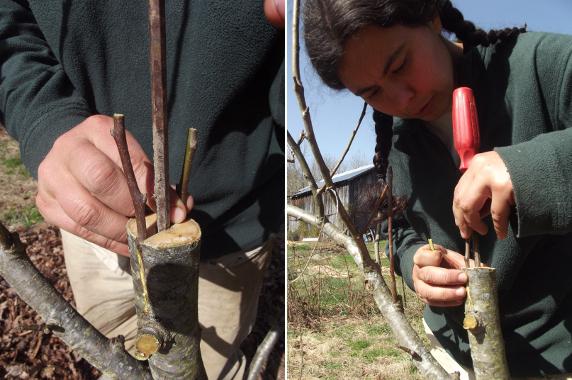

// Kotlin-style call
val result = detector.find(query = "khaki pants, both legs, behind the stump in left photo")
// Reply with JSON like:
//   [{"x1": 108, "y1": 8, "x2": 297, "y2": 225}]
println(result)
[{"x1": 61, "y1": 230, "x2": 274, "y2": 379}]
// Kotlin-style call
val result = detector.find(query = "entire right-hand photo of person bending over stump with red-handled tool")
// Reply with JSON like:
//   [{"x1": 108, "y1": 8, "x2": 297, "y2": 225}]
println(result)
[{"x1": 286, "y1": 0, "x2": 572, "y2": 379}]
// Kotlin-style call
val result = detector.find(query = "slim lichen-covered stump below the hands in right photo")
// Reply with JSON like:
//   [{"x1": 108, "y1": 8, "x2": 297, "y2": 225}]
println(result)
[{"x1": 463, "y1": 267, "x2": 510, "y2": 380}]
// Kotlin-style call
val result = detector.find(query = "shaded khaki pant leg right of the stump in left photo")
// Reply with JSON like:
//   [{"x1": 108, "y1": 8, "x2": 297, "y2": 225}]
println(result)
[{"x1": 199, "y1": 239, "x2": 274, "y2": 379}]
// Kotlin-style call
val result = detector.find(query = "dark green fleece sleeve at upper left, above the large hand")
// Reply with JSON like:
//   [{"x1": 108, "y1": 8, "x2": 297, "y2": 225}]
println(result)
[{"x1": 0, "y1": 0, "x2": 91, "y2": 177}]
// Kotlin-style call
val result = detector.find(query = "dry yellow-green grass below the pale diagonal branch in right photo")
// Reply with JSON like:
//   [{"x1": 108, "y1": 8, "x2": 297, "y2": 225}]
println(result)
[{"x1": 288, "y1": 242, "x2": 424, "y2": 379}]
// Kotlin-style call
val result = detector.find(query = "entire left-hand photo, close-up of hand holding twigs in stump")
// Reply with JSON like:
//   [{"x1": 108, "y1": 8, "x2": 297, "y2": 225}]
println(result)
[{"x1": 0, "y1": 0, "x2": 286, "y2": 379}]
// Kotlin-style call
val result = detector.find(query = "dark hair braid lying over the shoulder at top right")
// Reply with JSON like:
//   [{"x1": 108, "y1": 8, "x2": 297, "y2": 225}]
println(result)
[{"x1": 439, "y1": 0, "x2": 526, "y2": 47}]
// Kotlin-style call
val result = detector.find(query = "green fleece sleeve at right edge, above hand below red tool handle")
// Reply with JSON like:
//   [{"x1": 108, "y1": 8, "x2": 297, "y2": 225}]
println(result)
[{"x1": 495, "y1": 36, "x2": 572, "y2": 237}]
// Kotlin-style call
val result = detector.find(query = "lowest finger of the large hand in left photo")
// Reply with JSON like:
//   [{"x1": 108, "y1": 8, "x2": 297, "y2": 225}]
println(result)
[{"x1": 36, "y1": 194, "x2": 129, "y2": 256}]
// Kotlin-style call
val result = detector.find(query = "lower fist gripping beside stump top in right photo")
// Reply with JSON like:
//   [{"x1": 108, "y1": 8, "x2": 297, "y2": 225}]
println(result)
[{"x1": 413, "y1": 244, "x2": 467, "y2": 307}]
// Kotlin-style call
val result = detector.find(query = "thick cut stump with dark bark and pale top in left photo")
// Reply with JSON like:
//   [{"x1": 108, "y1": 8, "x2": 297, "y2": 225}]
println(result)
[{"x1": 127, "y1": 215, "x2": 206, "y2": 379}]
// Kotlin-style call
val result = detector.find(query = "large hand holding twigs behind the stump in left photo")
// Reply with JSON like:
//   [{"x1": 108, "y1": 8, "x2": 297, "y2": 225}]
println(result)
[{"x1": 36, "y1": 115, "x2": 188, "y2": 255}]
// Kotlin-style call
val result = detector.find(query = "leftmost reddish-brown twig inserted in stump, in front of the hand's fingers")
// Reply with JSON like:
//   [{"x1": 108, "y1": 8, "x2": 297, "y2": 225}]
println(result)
[{"x1": 111, "y1": 114, "x2": 147, "y2": 242}]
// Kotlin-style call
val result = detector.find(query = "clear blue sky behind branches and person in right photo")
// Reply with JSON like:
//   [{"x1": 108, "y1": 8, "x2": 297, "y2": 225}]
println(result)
[{"x1": 286, "y1": 0, "x2": 572, "y2": 163}]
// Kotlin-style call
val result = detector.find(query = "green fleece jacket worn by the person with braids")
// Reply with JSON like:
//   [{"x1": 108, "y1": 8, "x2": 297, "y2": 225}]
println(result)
[{"x1": 390, "y1": 32, "x2": 572, "y2": 376}]
